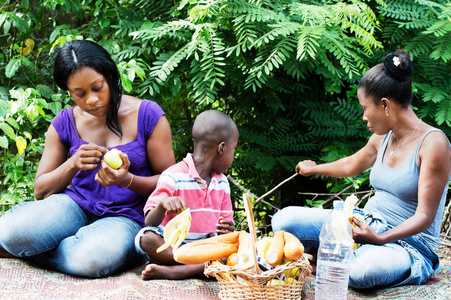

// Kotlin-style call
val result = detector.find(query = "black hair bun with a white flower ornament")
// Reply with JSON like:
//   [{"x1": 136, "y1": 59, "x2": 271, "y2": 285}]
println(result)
[{"x1": 382, "y1": 50, "x2": 413, "y2": 81}]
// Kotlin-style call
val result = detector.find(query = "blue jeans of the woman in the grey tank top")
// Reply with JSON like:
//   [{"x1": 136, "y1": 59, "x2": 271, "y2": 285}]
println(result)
[{"x1": 272, "y1": 206, "x2": 438, "y2": 288}]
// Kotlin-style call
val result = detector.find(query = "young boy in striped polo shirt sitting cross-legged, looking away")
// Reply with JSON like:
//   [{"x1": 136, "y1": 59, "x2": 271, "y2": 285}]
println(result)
[{"x1": 135, "y1": 110, "x2": 239, "y2": 280}]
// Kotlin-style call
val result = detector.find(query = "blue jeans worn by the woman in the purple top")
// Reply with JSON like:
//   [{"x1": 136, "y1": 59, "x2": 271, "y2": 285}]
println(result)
[{"x1": 0, "y1": 194, "x2": 142, "y2": 277}]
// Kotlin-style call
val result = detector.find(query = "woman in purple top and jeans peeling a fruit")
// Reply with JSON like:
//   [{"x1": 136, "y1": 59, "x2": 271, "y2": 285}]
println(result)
[{"x1": 0, "y1": 40, "x2": 175, "y2": 277}]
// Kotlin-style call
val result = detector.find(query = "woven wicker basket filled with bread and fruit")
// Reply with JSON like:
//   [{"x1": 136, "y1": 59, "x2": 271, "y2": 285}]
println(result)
[{"x1": 204, "y1": 255, "x2": 312, "y2": 300}]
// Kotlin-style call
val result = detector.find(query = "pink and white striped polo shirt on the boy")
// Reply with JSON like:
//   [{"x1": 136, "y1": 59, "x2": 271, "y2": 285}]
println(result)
[{"x1": 144, "y1": 153, "x2": 233, "y2": 234}]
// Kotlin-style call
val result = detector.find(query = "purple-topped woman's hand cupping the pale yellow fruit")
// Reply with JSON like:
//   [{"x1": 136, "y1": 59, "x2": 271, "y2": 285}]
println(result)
[{"x1": 95, "y1": 152, "x2": 130, "y2": 187}]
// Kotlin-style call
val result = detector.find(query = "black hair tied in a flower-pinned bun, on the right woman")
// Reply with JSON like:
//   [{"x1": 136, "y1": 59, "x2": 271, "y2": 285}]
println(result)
[{"x1": 358, "y1": 49, "x2": 413, "y2": 107}]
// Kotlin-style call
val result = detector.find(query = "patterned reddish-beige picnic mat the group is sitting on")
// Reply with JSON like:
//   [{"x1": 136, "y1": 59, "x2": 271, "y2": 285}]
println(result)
[{"x1": 0, "y1": 259, "x2": 451, "y2": 300}]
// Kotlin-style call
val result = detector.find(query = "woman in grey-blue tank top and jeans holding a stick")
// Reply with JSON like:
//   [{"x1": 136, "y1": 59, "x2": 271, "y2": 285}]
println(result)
[{"x1": 272, "y1": 50, "x2": 451, "y2": 288}]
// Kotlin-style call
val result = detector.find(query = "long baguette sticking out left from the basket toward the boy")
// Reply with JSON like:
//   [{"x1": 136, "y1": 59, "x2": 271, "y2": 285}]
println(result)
[{"x1": 173, "y1": 231, "x2": 240, "y2": 265}]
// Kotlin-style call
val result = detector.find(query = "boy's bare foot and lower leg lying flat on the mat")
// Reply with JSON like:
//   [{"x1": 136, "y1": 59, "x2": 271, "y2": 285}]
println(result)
[{"x1": 141, "y1": 264, "x2": 205, "y2": 280}]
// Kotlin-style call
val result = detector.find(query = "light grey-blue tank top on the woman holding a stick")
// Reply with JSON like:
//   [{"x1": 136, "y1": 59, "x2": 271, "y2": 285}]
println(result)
[{"x1": 364, "y1": 129, "x2": 451, "y2": 251}]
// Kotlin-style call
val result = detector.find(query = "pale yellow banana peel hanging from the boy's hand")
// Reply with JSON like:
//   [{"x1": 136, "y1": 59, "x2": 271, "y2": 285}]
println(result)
[{"x1": 157, "y1": 208, "x2": 191, "y2": 253}]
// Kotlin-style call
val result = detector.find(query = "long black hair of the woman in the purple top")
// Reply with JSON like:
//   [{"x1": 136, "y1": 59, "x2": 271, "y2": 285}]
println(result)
[{"x1": 53, "y1": 40, "x2": 122, "y2": 138}]
